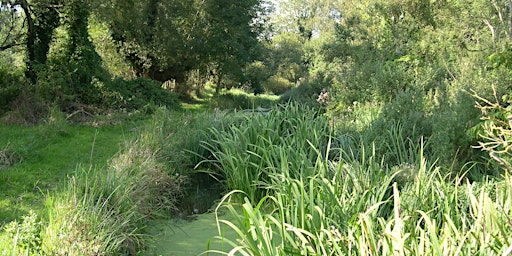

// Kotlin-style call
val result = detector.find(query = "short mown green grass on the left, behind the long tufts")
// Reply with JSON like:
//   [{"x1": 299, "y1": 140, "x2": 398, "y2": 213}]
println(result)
[{"x1": 0, "y1": 119, "x2": 135, "y2": 226}]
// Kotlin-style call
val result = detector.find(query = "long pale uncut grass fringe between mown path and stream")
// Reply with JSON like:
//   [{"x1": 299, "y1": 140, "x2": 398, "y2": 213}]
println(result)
[{"x1": 40, "y1": 126, "x2": 183, "y2": 255}]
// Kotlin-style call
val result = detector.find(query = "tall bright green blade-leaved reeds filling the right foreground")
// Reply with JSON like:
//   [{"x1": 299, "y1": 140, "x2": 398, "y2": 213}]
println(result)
[{"x1": 206, "y1": 104, "x2": 512, "y2": 255}]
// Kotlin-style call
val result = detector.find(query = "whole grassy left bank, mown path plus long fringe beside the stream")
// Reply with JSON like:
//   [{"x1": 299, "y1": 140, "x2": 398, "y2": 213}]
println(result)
[{"x1": 0, "y1": 101, "x2": 250, "y2": 255}]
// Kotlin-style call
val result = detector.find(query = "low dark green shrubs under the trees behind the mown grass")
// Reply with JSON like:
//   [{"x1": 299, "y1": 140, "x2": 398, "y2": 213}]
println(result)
[{"x1": 37, "y1": 55, "x2": 179, "y2": 111}]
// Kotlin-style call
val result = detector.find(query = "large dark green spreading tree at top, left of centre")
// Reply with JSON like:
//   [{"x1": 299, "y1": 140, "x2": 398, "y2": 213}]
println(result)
[{"x1": 98, "y1": 0, "x2": 266, "y2": 94}]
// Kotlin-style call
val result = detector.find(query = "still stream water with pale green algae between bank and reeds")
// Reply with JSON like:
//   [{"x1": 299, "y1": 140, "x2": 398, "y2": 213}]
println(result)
[{"x1": 141, "y1": 173, "x2": 236, "y2": 256}]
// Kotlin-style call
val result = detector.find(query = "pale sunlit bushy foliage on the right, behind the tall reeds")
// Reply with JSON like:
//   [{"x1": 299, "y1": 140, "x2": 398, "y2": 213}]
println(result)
[{"x1": 325, "y1": 1, "x2": 510, "y2": 174}]
